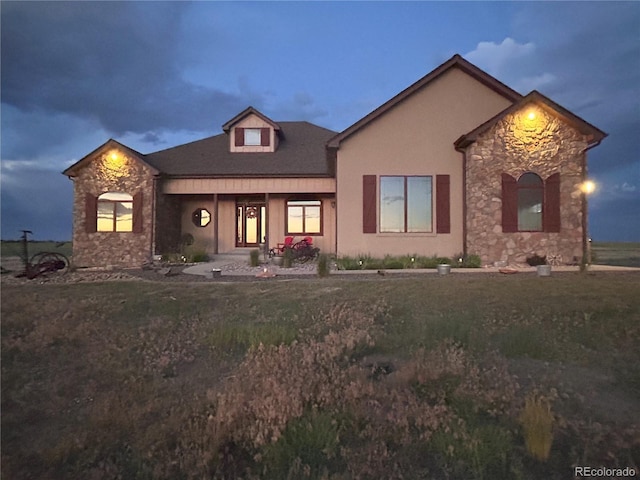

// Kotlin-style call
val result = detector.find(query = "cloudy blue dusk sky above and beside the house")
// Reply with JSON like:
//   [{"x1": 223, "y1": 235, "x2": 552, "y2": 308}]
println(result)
[{"x1": 0, "y1": 1, "x2": 640, "y2": 241}]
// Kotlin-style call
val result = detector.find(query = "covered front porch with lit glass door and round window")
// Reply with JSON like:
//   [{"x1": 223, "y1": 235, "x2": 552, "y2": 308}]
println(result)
[{"x1": 155, "y1": 178, "x2": 336, "y2": 256}]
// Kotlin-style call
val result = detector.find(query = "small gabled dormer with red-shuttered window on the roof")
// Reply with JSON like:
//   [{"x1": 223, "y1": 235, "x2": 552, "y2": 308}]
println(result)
[{"x1": 222, "y1": 107, "x2": 280, "y2": 153}]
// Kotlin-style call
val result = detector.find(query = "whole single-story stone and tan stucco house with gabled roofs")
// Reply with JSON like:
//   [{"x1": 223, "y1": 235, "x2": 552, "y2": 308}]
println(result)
[{"x1": 63, "y1": 55, "x2": 606, "y2": 266}]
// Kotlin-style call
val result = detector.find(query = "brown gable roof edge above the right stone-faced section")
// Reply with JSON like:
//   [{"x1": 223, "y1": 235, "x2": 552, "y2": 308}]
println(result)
[{"x1": 454, "y1": 90, "x2": 607, "y2": 150}]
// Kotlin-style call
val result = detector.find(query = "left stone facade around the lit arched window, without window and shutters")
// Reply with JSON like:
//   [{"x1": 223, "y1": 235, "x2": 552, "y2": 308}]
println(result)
[{"x1": 73, "y1": 150, "x2": 155, "y2": 267}]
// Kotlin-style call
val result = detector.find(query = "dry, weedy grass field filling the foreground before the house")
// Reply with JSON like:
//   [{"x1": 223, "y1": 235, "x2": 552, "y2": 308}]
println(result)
[{"x1": 1, "y1": 273, "x2": 640, "y2": 479}]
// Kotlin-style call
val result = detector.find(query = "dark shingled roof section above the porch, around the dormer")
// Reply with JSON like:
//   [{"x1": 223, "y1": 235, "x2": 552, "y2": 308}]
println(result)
[{"x1": 144, "y1": 122, "x2": 337, "y2": 177}]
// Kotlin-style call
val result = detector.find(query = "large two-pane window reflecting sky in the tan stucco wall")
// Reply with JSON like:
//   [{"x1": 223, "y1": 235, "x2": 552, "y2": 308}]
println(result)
[{"x1": 380, "y1": 176, "x2": 432, "y2": 233}]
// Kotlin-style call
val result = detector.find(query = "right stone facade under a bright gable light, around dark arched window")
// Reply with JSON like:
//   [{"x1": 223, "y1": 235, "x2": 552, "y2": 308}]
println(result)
[{"x1": 465, "y1": 105, "x2": 588, "y2": 263}]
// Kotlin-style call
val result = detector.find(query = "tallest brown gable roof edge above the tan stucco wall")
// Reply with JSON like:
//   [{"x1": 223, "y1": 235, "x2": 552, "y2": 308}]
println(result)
[{"x1": 327, "y1": 54, "x2": 522, "y2": 148}]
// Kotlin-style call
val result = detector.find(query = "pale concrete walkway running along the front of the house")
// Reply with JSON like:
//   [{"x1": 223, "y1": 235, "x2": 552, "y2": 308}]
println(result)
[{"x1": 183, "y1": 254, "x2": 640, "y2": 278}]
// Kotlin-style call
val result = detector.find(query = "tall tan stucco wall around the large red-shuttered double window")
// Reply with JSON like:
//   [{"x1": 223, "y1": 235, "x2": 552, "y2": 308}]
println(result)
[{"x1": 336, "y1": 69, "x2": 510, "y2": 256}]
